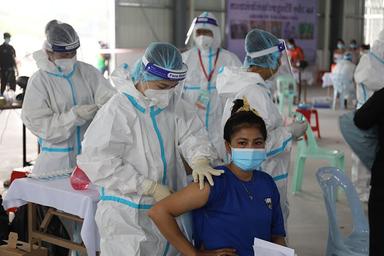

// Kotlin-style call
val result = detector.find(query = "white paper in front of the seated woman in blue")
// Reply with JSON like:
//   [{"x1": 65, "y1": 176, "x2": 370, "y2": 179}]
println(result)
[{"x1": 253, "y1": 238, "x2": 295, "y2": 256}]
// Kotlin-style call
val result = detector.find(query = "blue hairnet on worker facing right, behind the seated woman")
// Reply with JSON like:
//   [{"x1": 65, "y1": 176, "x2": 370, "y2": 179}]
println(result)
[{"x1": 243, "y1": 29, "x2": 280, "y2": 69}]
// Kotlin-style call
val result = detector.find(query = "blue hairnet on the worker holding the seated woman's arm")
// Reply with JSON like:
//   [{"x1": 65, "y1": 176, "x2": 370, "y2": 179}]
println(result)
[{"x1": 131, "y1": 43, "x2": 183, "y2": 83}]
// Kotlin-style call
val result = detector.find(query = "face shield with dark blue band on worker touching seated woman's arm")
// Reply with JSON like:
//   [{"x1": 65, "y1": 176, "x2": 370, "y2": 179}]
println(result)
[{"x1": 142, "y1": 56, "x2": 188, "y2": 104}]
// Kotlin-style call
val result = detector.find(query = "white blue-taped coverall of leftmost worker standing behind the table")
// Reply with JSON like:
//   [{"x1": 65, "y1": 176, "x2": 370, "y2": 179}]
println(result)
[{"x1": 21, "y1": 50, "x2": 116, "y2": 176}]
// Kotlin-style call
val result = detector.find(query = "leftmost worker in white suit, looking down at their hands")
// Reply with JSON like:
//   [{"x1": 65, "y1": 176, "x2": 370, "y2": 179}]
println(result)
[{"x1": 21, "y1": 20, "x2": 116, "y2": 176}]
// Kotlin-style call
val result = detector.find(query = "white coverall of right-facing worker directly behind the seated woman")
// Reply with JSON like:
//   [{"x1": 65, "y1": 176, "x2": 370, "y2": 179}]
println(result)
[{"x1": 217, "y1": 67, "x2": 292, "y2": 223}]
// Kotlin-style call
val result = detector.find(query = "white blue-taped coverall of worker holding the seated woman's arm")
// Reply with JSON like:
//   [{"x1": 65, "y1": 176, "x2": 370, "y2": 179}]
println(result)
[{"x1": 78, "y1": 77, "x2": 218, "y2": 256}]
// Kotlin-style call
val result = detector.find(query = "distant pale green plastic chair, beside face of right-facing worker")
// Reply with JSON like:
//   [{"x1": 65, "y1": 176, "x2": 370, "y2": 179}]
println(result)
[{"x1": 276, "y1": 75, "x2": 297, "y2": 117}]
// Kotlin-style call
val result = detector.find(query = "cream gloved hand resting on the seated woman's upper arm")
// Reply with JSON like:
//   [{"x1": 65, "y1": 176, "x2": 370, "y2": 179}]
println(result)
[{"x1": 191, "y1": 157, "x2": 224, "y2": 189}]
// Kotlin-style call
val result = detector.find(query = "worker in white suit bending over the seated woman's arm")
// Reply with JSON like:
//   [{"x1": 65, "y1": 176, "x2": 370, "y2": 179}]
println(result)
[{"x1": 78, "y1": 43, "x2": 221, "y2": 256}]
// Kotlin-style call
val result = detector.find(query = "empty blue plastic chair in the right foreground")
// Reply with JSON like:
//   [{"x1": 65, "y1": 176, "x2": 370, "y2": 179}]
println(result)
[{"x1": 316, "y1": 167, "x2": 369, "y2": 256}]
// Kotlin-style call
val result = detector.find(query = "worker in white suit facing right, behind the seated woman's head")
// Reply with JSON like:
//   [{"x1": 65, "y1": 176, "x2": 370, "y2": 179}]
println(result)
[{"x1": 217, "y1": 29, "x2": 307, "y2": 225}]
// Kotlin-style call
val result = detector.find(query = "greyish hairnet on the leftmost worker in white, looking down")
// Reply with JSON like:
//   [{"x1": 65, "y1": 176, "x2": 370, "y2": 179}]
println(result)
[{"x1": 45, "y1": 20, "x2": 80, "y2": 51}]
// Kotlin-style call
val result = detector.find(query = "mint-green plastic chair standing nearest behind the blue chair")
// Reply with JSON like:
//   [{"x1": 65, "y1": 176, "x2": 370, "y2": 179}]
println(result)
[{"x1": 292, "y1": 113, "x2": 344, "y2": 194}]
